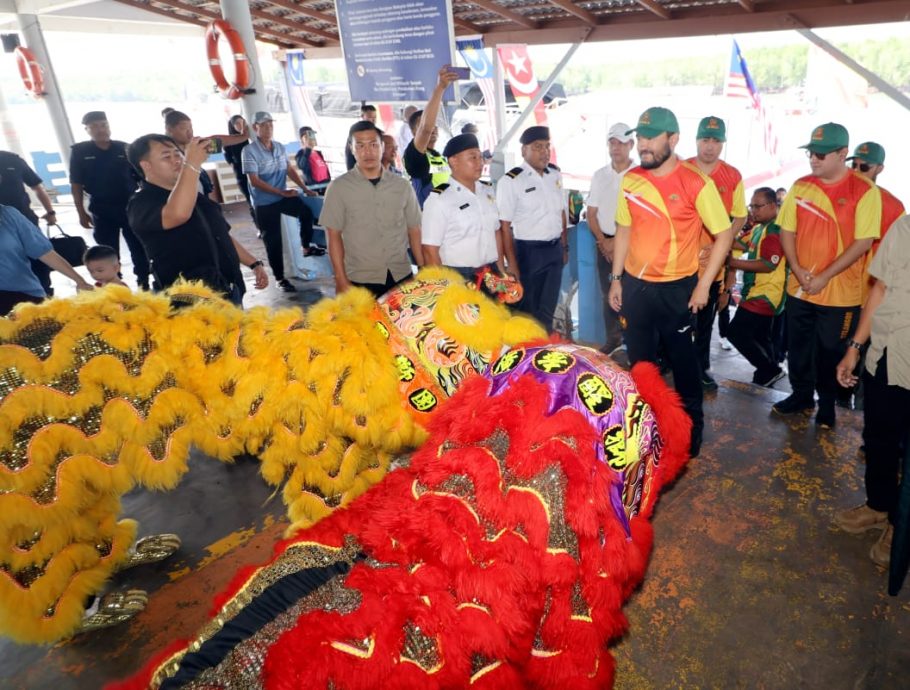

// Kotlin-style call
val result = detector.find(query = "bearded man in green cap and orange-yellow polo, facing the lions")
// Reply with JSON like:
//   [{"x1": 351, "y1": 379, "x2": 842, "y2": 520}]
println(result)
[{"x1": 610, "y1": 108, "x2": 733, "y2": 457}]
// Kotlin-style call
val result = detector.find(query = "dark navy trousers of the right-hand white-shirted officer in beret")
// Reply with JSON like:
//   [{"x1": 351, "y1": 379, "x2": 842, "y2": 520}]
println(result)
[{"x1": 515, "y1": 237, "x2": 563, "y2": 331}]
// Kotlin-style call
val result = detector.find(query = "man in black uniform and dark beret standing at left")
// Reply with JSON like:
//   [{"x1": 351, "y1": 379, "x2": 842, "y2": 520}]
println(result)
[{"x1": 70, "y1": 110, "x2": 149, "y2": 290}]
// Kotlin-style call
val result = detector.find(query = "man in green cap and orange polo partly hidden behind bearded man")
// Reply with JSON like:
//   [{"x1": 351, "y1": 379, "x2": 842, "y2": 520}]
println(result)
[{"x1": 688, "y1": 115, "x2": 748, "y2": 391}]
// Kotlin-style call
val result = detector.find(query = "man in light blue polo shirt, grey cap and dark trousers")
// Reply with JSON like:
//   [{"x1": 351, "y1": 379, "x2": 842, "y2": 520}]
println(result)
[{"x1": 243, "y1": 110, "x2": 316, "y2": 292}]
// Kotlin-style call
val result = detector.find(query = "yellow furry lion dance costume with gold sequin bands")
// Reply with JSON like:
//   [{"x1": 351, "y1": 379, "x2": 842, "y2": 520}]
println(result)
[{"x1": 0, "y1": 269, "x2": 545, "y2": 643}]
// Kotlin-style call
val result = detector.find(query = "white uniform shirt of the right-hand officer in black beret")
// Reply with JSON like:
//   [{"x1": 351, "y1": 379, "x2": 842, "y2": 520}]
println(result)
[{"x1": 496, "y1": 163, "x2": 568, "y2": 241}]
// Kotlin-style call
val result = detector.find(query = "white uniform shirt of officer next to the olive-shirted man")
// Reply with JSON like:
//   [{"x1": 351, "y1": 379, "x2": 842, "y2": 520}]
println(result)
[{"x1": 420, "y1": 178, "x2": 499, "y2": 268}]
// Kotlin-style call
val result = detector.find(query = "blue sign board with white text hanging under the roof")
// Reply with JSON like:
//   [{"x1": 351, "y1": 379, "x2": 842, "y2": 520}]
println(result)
[{"x1": 335, "y1": 0, "x2": 454, "y2": 103}]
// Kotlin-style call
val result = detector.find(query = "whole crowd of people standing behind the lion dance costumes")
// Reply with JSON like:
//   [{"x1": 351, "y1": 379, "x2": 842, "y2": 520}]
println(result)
[{"x1": 0, "y1": 67, "x2": 910, "y2": 561}]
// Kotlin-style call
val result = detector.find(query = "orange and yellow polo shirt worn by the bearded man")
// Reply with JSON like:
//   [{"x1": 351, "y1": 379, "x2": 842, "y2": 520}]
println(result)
[{"x1": 616, "y1": 161, "x2": 730, "y2": 283}]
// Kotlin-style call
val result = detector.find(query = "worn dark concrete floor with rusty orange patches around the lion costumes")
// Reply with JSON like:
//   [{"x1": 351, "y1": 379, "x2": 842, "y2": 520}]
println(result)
[{"x1": 0, "y1": 206, "x2": 910, "y2": 690}]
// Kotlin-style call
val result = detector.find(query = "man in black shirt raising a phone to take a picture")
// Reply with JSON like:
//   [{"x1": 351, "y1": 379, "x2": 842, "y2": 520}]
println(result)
[{"x1": 127, "y1": 134, "x2": 269, "y2": 306}]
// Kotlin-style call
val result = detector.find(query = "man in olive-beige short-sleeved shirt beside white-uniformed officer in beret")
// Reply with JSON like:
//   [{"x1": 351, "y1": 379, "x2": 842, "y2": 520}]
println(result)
[{"x1": 319, "y1": 121, "x2": 423, "y2": 297}]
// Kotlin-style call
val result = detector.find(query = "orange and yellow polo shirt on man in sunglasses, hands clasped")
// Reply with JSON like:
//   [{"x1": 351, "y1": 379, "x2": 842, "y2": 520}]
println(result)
[{"x1": 777, "y1": 170, "x2": 882, "y2": 307}]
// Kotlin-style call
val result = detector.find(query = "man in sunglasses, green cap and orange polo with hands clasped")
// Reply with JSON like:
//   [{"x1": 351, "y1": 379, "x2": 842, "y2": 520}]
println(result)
[{"x1": 772, "y1": 122, "x2": 882, "y2": 429}]
